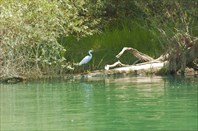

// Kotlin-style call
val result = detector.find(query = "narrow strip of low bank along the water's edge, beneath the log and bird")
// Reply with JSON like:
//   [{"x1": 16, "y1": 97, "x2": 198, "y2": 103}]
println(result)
[{"x1": 0, "y1": 68, "x2": 198, "y2": 84}]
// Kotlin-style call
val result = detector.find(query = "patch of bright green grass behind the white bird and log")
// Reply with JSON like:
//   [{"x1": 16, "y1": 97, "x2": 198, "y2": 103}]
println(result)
[{"x1": 61, "y1": 21, "x2": 161, "y2": 70}]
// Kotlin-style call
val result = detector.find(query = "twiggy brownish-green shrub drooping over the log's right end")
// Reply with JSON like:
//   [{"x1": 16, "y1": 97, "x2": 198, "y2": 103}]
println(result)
[{"x1": 137, "y1": 0, "x2": 198, "y2": 73}]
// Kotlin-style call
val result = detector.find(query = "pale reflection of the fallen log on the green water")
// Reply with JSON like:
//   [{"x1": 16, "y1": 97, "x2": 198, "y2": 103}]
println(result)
[{"x1": 105, "y1": 77, "x2": 164, "y2": 97}]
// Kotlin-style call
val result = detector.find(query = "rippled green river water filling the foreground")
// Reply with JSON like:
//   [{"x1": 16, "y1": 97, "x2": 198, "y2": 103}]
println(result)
[{"x1": 0, "y1": 77, "x2": 198, "y2": 131}]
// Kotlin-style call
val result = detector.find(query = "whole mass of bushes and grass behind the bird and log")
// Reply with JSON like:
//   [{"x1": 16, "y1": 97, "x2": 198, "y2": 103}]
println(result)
[{"x1": 0, "y1": 0, "x2": 198, "y2": 78}]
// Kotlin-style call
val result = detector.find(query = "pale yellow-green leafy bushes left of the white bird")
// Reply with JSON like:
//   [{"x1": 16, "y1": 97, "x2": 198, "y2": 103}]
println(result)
[{"x1": 0, "y1": 0, "x2": 99, "y2": 76}]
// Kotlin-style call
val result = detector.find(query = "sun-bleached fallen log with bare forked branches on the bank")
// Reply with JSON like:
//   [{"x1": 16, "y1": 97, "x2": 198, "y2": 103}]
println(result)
[{"x1": 105, "y1": 44, "x2": 198, "y2": 74}]
